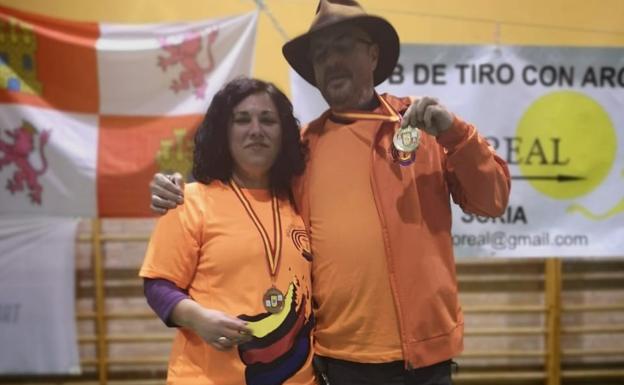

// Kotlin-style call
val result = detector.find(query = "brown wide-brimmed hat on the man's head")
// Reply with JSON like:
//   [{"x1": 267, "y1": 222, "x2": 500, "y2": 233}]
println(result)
[{"x1": 282, "y1": 0, "x2": 400, "y2": 86}]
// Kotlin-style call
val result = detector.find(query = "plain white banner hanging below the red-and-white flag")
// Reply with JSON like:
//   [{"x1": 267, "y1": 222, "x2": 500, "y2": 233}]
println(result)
[{"x1": 0, "y1": 217, "x2": 80, "y2": 375}]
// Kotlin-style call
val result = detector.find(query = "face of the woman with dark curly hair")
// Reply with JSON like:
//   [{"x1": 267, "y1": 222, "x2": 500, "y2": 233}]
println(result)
[{"x1": 228, "y1": 92, "x2": 282, "y2": 183}]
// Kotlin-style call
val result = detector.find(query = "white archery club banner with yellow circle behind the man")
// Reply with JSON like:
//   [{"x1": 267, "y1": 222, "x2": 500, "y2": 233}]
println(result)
[{"x1": 291, "y1": 45, "x2": 624, "y2": 257}]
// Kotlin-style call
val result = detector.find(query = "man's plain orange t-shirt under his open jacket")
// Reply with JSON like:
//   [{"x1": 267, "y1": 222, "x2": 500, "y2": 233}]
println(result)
[{"x1": 308, "y1": 116, "x2": 403, "y2": 363}]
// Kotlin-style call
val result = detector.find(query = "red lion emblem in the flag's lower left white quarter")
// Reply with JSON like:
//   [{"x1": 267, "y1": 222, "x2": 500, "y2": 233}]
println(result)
[{"x1": 0, "y1": 121, "x2": 50, "y2": 205}]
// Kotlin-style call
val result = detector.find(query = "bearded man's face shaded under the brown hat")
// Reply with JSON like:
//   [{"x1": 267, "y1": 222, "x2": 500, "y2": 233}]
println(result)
[{"x1": 309, "y1": 26, "x2": 379, "y2": 110}]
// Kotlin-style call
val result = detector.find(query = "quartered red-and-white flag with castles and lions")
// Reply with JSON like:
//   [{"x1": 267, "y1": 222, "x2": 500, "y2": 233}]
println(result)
[{"x1": 0, "y1": 7, "x2": 257, "y2": 217}]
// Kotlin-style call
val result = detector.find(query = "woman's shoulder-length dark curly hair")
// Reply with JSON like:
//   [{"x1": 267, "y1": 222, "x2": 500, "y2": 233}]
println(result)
[{"x1": 193, "y1": 77, "x2": 305, "y2": 196}]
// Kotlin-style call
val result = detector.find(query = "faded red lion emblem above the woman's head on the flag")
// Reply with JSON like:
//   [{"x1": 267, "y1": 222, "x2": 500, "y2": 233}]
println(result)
[{"x1": 158, "y1": 29, "x2": 219, "y2": 99}]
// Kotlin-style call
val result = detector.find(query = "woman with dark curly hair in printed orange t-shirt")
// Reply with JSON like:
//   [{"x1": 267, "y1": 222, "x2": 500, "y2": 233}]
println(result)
[{"x1": 140, "y1": 78, "x2": 314, "y2": 385}]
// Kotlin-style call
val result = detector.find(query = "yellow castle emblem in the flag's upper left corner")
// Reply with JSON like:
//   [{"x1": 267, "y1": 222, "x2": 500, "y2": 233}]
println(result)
[{"x1": 0, "y1": 19, "x2": 42, "y2": 95}]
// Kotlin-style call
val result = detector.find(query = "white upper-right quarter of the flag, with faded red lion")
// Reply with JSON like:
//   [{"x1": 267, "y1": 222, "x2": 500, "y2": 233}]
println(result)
[{"x1": 96, "y1": 12, "x2": 258, "y2": 116}]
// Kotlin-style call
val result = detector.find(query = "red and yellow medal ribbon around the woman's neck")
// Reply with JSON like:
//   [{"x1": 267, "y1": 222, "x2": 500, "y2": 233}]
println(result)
[{"x1": 230, "y1": 179, "x2": 282, "y2": 280}]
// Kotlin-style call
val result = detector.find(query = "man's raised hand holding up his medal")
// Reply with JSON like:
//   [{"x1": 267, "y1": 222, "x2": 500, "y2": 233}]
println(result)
[{"x1": 401, "y1": 96, "x2": 453, "y2": 136}]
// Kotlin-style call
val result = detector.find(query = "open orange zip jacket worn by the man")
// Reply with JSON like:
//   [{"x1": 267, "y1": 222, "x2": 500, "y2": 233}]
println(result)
[{"x1": 294, "y1": 94, "x2": 510, "y2": 368}]
